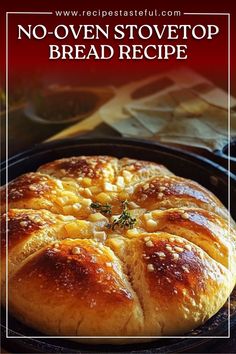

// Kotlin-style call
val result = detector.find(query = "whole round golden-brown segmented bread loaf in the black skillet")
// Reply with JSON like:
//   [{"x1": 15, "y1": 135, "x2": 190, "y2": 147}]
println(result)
[{"x1": 1, "y1": 156, "x2": 236, "y2": 343}]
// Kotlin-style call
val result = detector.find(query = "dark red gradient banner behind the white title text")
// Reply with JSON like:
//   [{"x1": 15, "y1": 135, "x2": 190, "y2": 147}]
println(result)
[{"x1": 0, "y1": 0, "x2": 236, "y2": 94}]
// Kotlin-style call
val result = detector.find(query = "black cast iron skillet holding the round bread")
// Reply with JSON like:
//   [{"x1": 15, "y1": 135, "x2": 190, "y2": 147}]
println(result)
[{"x1": 1, "y1": 138, "x2": 236, "y2": 354}]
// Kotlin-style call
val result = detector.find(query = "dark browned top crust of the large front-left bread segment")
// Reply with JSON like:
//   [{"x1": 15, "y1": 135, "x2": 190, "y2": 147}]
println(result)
[{"x1": 15, "y1": 240, "x2": 132, "y2": 307}]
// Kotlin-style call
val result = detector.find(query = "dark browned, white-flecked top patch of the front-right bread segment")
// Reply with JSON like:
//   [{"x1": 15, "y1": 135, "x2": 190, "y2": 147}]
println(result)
[{"x1": 142, "y1": 234, "x2": 221, "y2": 301}]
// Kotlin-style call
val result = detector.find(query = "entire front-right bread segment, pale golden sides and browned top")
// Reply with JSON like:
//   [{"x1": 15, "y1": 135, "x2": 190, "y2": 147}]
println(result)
[{"x1": 125, "y1": 233, "x2": 233, "y2": 335}]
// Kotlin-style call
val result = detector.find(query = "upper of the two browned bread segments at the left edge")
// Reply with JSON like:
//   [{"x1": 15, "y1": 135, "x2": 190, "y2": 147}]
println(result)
[{"x1": 1, "y1": 172, "x2": 97, "y2": 217}]
